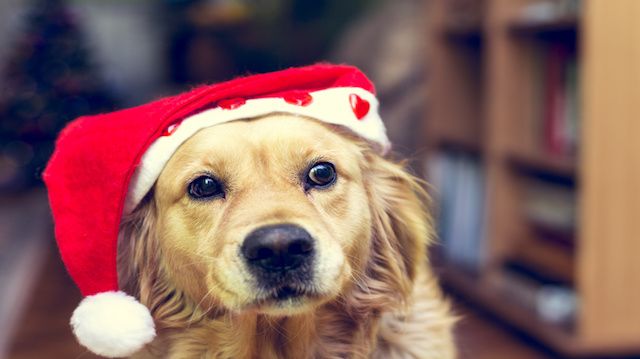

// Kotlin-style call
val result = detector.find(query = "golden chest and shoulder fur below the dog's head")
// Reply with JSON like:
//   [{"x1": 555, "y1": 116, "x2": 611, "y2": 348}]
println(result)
[{"x1": 132, "y1": 274, "x2": 454, "y2": 359}]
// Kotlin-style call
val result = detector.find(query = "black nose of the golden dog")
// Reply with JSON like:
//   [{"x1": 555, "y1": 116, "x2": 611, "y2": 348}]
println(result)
[{"x1": 242, "y1": 224, "x2": 313, "y2": 272}]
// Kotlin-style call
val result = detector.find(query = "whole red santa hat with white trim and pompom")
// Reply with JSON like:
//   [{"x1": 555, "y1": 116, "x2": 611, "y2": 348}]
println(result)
[{"x1": 44, "y1": 64, "x2": 389, "y2": 357}]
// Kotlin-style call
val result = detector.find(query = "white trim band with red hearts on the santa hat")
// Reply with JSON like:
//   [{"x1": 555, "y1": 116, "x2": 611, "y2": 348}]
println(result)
[{"x1": 124, "y1": 87, "x2": 391, "y2": 214}]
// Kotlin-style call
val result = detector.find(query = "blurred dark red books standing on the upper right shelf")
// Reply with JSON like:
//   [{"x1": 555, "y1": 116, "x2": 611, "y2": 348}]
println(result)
[{"x1": 531, "y1": 41, "x2": 580, "y2": 157}]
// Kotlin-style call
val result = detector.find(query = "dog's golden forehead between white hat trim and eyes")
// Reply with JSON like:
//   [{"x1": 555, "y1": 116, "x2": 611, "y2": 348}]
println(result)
[{"x1": 158, "y1": 115, "x2": 363, "y2": 188}]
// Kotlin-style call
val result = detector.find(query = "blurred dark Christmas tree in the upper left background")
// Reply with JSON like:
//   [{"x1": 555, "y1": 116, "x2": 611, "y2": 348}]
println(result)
[{"x1": 0, "y1": 0, "x2": 114, "y2": 190}]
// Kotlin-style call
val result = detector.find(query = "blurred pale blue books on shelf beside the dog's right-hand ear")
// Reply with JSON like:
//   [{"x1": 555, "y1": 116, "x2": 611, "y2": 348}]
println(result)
[{"x1": 427, "y1": 151, "x2": 485, "y2": 271}]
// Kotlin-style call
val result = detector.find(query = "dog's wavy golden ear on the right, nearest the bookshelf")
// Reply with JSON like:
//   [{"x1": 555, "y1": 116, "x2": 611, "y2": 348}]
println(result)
[{"x1": 354, "y1": 152, "x2": 432, "y2": 316}]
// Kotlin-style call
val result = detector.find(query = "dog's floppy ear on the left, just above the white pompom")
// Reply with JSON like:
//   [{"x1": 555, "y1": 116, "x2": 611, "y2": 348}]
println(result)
[{"x1": 118, "y1": 194, "x2": 202, "y2": 329}]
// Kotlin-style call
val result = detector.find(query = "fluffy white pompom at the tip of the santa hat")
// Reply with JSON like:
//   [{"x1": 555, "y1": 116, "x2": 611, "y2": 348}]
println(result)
[{"x1": 71, "y1": 292, "x2": 156, "y2": 358}]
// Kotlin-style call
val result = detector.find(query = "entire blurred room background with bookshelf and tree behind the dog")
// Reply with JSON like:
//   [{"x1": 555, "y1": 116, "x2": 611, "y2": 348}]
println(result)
[{"x1": 0, "y1": 0, "x2": 640, "y2": 359}]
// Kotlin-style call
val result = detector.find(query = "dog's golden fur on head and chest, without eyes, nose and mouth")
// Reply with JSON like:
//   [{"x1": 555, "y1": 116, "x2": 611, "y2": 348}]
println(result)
[{"x1": 118, "y1": 114, "x2": 455, "y2": 359}]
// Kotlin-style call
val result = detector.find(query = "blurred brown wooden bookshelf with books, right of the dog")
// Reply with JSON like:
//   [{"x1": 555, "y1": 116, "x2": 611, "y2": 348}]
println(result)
[{"x1": 425, "y1": 0, "x2": 640, "y2": 356}]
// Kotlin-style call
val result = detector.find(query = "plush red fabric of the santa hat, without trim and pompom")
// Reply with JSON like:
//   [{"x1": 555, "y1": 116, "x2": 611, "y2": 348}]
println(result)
[{"x1": 43, "y1": 64, "x2": 375, "y2": 296}]
